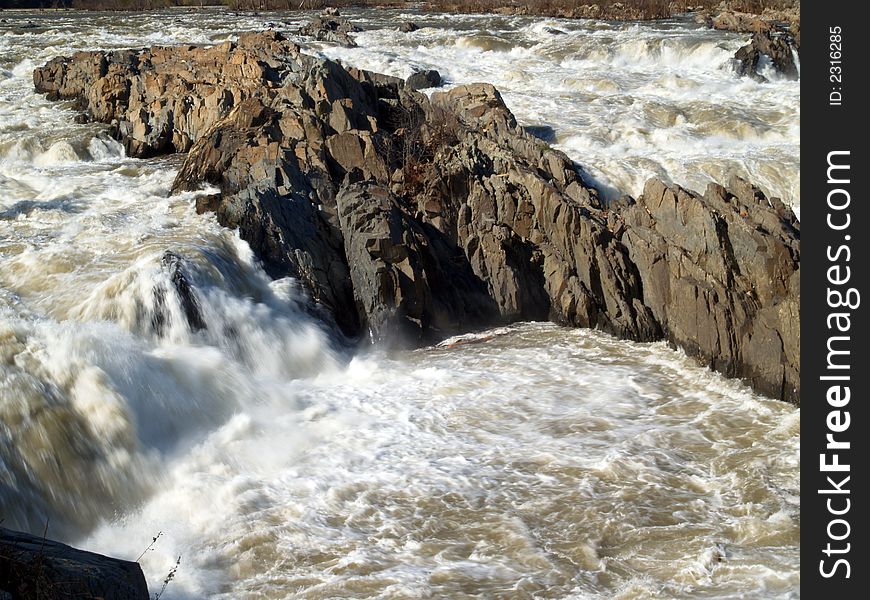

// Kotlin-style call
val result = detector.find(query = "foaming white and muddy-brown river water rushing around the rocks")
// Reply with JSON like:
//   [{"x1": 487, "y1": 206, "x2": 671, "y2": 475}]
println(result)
[{"x1": 0, "y1": 5, "x2": 800, "y2": 599}]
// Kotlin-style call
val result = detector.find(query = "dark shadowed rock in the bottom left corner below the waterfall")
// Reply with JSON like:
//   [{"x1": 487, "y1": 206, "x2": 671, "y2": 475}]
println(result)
[{"x1": 0, "y1": 527, "x2": 149, "y2": 600}]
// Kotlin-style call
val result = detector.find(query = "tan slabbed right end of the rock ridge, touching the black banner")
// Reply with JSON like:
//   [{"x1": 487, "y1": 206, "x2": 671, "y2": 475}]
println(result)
[{"x1": 618, "y1": 178, "x2": 800, "y2": 402}]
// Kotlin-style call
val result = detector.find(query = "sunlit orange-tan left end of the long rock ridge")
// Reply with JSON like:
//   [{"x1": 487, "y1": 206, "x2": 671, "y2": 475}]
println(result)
[{"x1": 33, "y1": 34, "x2": 304, "y2": 158}]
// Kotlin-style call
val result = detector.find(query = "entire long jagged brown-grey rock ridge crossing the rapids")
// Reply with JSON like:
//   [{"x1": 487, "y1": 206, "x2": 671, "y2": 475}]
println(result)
[{"x1": 34, "y1": 32, "x2": 800, "y2": 401}]
